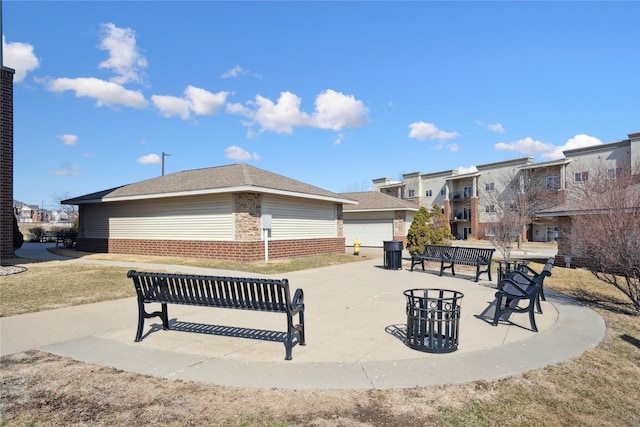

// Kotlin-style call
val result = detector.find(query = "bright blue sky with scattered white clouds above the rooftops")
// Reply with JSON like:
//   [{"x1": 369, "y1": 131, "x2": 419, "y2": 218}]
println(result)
[{"x1": 2, "y1": 0, "x2": 640, "y2": 209}]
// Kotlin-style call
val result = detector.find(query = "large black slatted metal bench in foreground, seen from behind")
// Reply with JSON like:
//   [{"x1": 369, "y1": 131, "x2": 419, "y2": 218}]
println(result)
[{"x1": 127, "y1": 270, "x2": 305, "y2": 360}]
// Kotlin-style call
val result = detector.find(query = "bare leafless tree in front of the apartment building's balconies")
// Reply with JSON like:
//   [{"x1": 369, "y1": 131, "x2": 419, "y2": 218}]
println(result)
[{"x1": 483, "y1": 168, "x2": 558, "y2": 261}]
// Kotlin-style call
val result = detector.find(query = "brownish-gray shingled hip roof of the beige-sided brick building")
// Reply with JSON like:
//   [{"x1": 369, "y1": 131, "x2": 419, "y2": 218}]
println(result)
[{"x1": 63, "y1": 164, "x2": 354, "y2": 205}]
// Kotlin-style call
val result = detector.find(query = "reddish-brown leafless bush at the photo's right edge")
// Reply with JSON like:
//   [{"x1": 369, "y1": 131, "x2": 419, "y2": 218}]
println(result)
[{"x1": 570, "y1": 163, "x2": 640, "y2": 314}]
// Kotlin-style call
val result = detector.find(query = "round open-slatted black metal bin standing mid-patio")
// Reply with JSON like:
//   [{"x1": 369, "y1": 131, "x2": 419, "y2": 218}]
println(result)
[{"x1": 404, "y1": 289, "x2": 464, "y2": 353}]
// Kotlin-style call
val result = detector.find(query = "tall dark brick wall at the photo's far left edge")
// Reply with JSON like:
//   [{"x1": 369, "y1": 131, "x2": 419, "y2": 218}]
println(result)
[{"x1": 0, "y1": 67, "x2": 14, "y2": 258}]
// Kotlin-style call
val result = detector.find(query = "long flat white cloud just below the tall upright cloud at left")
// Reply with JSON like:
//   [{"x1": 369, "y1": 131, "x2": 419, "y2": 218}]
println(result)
[{"x1": 47, "y1": 77, "x2": 147, "y2": 108}]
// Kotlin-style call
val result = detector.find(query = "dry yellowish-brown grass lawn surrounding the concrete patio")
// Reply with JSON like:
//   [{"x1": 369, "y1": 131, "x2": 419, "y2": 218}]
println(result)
[{"x1": 0, "y1": 249, "x2": 640, "y2": 427}]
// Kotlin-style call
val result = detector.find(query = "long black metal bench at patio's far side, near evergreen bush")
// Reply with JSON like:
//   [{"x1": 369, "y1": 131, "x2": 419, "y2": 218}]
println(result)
[{"x1": 411, "y1": 245, "x2": 495, "y2": 282}]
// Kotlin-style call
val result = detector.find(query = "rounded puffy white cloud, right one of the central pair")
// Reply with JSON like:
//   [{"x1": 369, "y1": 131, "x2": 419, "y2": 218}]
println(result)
[{"x1": 313, "y1": 89, "x2": 368, "y2": 131}]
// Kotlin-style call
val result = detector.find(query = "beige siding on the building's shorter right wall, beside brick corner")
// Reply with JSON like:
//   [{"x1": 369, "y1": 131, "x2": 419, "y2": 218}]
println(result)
[{"x1": 262, "y1": 196, "x2": 338, "y2": 240}]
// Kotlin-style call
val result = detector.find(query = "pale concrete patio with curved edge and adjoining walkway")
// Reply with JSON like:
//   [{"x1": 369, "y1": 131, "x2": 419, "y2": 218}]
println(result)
[{"x1": 0, "y1": 244, "x2": 605, "y2": 389}]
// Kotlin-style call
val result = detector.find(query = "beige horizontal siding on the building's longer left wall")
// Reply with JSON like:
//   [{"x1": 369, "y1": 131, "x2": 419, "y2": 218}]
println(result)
[{"x1": 83, "y1": 194, "x2": 234, "y2": 241}]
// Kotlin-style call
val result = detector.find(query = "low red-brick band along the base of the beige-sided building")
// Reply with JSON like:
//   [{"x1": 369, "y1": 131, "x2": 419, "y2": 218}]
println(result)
[{"x1": 76, "y1": 237, "x2": 344, "y2": 262}]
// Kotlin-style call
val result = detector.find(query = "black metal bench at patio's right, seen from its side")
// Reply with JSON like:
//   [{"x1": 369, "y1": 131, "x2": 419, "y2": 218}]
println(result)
[{"x1": 493, "y1": 262, "x2": 553, "y2": 332}]
